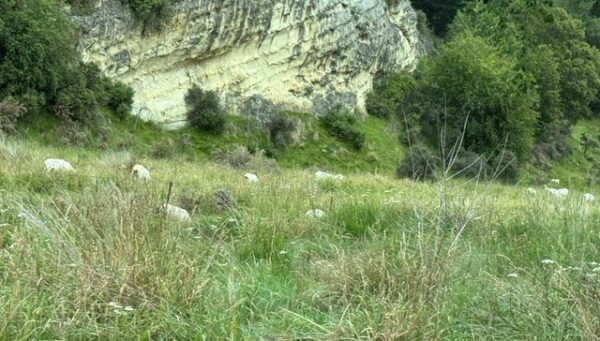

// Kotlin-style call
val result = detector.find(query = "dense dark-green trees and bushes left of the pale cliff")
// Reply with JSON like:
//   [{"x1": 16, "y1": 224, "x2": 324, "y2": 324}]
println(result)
[{"x1": 0, "y1": 0, "x2": 133, "y2": 130}]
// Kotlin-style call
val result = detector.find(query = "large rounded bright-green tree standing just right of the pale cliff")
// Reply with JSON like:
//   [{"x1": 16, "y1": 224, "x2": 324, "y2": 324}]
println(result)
[{"x1": 421, "y1": 33, "x2": 538, "y2": 159}]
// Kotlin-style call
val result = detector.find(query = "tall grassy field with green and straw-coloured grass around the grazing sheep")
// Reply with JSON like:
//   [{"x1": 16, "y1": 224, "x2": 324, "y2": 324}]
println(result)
[{"x1": 0, "y1": 136, "x2": 600, "y2": 340}]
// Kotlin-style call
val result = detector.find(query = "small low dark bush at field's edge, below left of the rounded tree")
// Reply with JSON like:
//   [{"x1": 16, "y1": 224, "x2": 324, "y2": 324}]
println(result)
[{"x1": 396, "y1": 146, "x2": 440, "y2": 181}]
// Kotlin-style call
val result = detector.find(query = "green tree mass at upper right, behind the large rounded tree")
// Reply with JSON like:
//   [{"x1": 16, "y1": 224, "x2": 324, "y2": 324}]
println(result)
[{"x1": 451, "y1": 0, "x2": 600, "y2": 125}]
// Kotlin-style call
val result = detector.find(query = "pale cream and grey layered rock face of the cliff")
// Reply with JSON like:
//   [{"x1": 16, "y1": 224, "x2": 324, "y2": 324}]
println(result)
[{"x1": 76, "y1": 0, "x2": 423, "y2": 128}]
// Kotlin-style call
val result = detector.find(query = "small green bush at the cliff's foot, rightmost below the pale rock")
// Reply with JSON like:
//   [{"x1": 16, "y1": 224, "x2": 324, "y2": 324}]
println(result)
[{"x1": 321, "y1": 105, "x2": 365, "y2": 150}]
